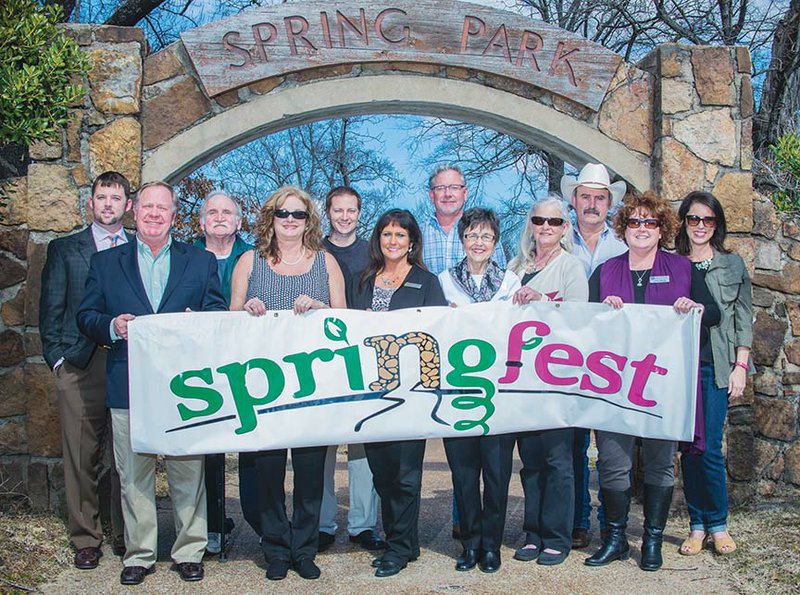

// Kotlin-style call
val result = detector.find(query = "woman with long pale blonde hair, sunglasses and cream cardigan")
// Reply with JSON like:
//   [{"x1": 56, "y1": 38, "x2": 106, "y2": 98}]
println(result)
[{"x1": 509, "y1": 196, "x2": 589, "y2": 566}]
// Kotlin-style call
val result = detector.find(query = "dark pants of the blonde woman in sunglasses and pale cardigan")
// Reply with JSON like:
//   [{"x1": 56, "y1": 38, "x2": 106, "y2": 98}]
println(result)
[{"x1": 517, "y1": 428, "x2": 575, "y2": 552}]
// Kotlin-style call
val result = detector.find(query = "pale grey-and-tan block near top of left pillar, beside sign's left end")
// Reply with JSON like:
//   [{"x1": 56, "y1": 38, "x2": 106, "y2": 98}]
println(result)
[{"x1": 89, "y1": 43, "x2": 142, "y2": 114}]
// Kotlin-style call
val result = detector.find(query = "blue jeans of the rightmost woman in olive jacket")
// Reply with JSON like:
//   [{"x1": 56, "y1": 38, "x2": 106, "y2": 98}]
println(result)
[{"x1": 681, "y1": 363, "x2": 728, "y2": 533}]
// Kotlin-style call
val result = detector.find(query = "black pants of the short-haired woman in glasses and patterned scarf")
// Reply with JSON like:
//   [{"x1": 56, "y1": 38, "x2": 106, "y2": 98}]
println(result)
[{"x1": 444, "y1": 434, "x2": 515, "y2": 550}]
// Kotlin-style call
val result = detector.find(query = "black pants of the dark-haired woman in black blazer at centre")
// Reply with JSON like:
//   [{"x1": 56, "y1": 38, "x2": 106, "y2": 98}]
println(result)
[{"x1": 364, "y1": 440, "x2": 425, "y2": 565}]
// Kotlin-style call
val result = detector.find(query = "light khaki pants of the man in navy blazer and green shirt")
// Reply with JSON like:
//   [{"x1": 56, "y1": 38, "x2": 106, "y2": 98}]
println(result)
[{"x1": 111, "y1": 409, "x2": 208, "y2": 567}]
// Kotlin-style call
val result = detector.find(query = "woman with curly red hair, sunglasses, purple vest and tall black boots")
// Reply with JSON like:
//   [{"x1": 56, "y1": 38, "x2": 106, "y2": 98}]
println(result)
[{"x1": 584, "y1": 192, "x2": 720, "y2": 571}]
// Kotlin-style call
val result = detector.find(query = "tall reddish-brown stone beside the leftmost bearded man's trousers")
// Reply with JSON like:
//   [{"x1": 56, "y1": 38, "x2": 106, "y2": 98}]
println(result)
[{"x1": 25, "y1": 363, "x2": 61, "y2": 457}]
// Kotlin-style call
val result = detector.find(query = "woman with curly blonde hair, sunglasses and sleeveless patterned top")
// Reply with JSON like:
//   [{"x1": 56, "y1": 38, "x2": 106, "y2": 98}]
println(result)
[{"x1": 231, "y1": 186, "x2": 346, "y2": 580}]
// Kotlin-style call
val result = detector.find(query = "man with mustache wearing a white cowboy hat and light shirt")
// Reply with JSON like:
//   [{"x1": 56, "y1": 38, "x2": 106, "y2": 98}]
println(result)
[{"x1": 561, "y1": 163, "x2": 628, "y2": 549}]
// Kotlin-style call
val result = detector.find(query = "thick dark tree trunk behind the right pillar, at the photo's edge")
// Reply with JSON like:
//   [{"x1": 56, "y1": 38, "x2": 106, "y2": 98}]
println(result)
[{"x1": 753, "y1": 0, "x2": 800, "y2": 157}]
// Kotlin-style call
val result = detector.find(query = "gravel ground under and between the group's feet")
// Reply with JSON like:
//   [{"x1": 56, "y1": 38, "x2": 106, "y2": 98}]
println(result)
[{"x1": 40, "y1": 440, "x2": 741, "y2": 595}]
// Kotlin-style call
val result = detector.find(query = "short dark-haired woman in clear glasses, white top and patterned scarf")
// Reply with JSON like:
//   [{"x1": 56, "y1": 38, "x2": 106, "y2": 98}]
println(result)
[{"x1": 439, "y1": 208, "x2": 520, "y2": 572}]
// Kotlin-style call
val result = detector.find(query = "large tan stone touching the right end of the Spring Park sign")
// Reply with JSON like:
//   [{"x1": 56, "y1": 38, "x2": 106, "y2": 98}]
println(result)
[{"x1": 597, "y1": 65, "x2": 653, "y2": 155}]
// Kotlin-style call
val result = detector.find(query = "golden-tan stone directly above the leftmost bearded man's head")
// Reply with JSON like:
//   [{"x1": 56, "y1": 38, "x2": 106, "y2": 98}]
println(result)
[{"x1": 89, "y1": 118, "x2": 142, "y2": 188}]
